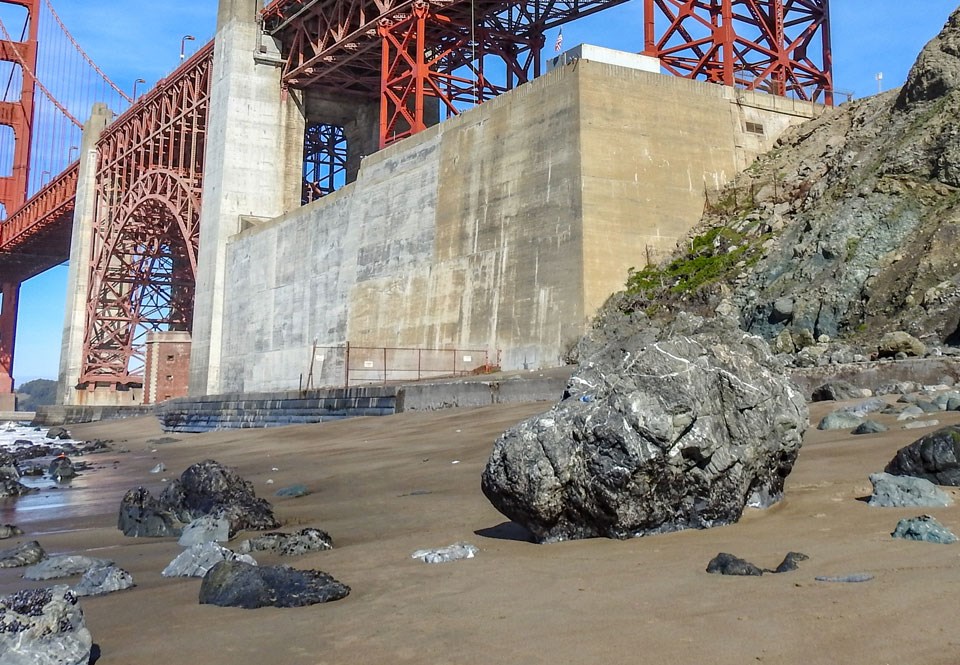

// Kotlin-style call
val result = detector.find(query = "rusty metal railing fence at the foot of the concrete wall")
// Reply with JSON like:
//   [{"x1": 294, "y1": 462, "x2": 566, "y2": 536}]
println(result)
[{"x1": 300, "y1": 342, "x2": 500, "y2": 390}]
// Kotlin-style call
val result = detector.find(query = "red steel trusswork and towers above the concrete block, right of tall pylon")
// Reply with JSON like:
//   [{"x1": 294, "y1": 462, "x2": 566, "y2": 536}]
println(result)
[{"x1": 262, "y1": 0, "x2": 833, "y2": 144}]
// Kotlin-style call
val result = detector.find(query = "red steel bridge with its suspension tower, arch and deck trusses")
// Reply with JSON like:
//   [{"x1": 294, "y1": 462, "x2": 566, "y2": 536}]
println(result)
[{"x1": 0, "y1": 0, "x2": 833, "y2": 394}]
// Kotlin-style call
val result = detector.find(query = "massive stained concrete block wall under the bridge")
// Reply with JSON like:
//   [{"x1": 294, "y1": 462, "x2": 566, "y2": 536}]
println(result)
[{"x1": 214, "y1": 61, "x2": 819, "y2": 392}]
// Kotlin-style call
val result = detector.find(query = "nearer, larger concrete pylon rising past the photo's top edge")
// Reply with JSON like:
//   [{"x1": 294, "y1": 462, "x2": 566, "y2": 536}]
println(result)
[{"x1": 189, "y1": 0, "x2": 304, "y2": 395}]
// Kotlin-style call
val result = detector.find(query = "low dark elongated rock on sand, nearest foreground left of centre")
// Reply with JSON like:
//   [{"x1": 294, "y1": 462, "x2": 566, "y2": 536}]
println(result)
[{"x1": 200, "y1": 561, "x2": 350, "y2": 609}]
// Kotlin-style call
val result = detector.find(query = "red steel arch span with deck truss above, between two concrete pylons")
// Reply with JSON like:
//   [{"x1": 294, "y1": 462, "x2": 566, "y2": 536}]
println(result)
[{"x1": 78, "y1": 43, "x2": 213, "y2": 388}]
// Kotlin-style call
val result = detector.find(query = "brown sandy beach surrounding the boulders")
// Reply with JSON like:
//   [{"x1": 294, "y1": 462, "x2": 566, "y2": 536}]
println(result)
[{"x1": 0, "y1": 404, "x2": 960, "y2": 665}]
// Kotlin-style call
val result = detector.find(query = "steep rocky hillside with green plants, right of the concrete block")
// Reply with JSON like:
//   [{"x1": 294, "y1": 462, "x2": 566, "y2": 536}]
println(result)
[{"x1": 612, "y1": 10, "x2": 960, "y2": 345}]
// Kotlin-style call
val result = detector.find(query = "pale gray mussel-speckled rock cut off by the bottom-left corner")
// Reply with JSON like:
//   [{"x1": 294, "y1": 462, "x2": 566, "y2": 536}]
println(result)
[{"x1": 0, "y1": 586, "x2": 93, "y2": 665}]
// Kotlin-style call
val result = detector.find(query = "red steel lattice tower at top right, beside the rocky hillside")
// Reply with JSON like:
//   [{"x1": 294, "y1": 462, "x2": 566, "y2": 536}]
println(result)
[{"x1": 644, "y1": 0, "x2": 833, "y2": 104}]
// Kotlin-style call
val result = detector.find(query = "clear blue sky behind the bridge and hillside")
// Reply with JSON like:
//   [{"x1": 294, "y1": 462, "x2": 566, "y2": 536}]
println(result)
[{"x1": 8, "y1": 0, "x2": 960, "y2": 384}]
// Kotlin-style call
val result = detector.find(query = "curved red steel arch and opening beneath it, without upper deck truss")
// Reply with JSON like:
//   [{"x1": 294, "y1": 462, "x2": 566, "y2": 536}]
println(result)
[{"x1": 80, "y1": 170, "x2": 200, "y2": 385}]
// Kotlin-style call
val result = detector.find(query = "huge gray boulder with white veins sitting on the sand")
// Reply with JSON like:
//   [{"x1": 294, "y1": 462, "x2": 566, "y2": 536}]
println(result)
[{"x1": 481, "y1": 316, "x2": 808, "y2": 542}]
